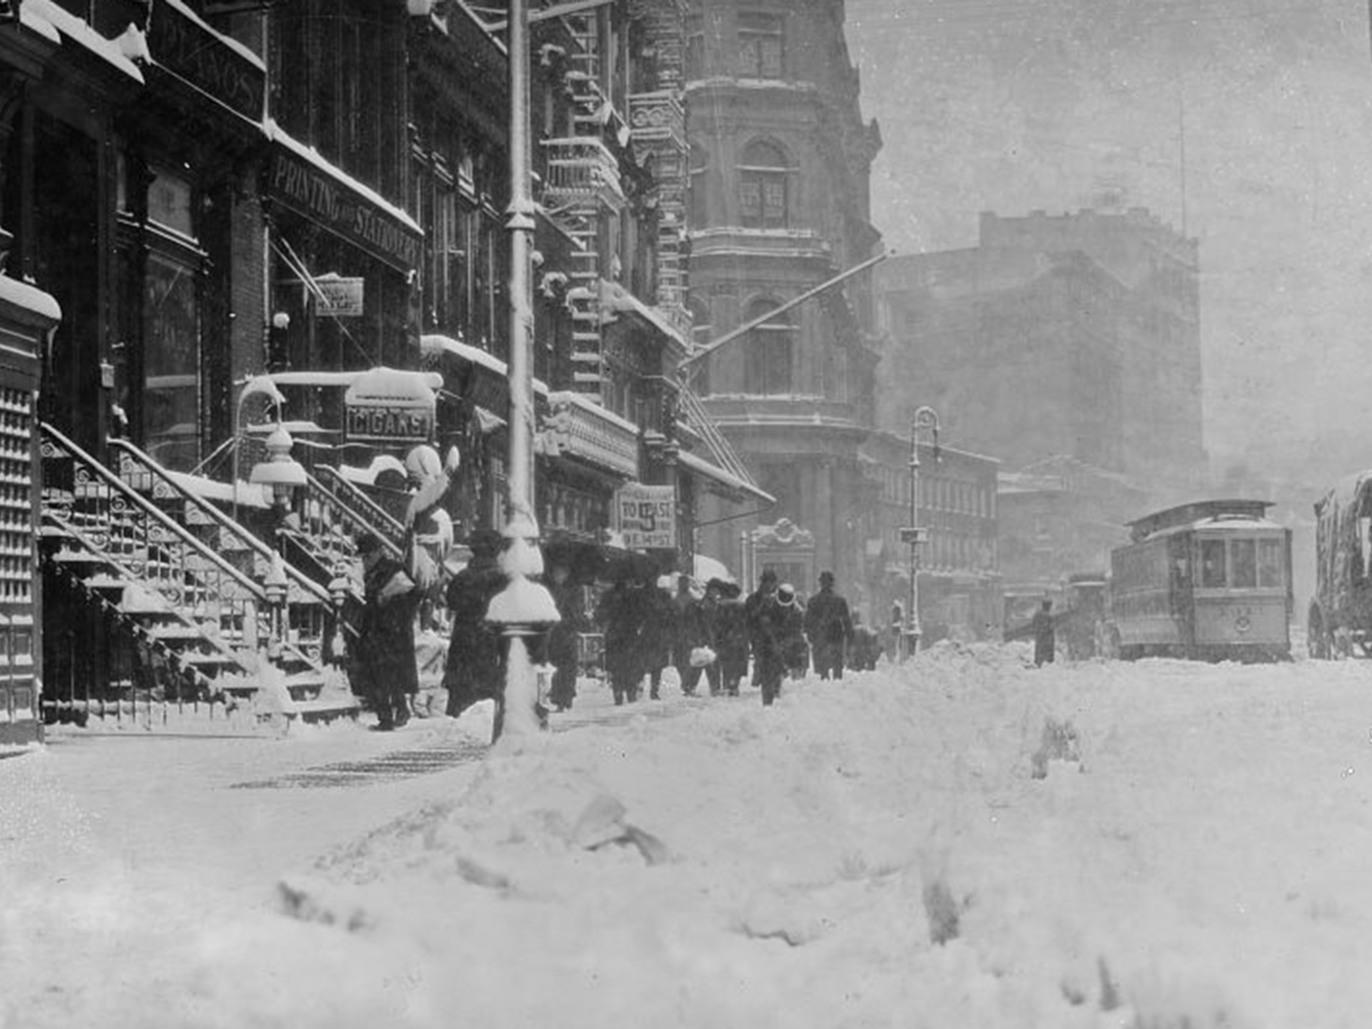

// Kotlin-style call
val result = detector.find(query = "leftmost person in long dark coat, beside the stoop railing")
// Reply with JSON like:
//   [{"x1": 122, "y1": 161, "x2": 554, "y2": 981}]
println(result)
[{"x1": 351, "y1": 532, "x2": 420, "y2": 731}]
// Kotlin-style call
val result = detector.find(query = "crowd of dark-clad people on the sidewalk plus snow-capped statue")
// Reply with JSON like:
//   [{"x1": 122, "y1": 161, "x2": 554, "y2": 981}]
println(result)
[{"x1": 348, "y1": 446, "x2": 905, "y2": 730}]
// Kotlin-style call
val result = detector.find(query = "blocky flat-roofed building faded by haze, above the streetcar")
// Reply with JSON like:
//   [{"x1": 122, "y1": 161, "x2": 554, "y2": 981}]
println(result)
[{"x1": 878, "y1": 207, "x2": 1206, "y2": 502}]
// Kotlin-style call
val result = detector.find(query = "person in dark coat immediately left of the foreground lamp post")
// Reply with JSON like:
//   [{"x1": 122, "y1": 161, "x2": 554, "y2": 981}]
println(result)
[{"x1": 443, "y1": 530, "x2": 505, "y2": 718}]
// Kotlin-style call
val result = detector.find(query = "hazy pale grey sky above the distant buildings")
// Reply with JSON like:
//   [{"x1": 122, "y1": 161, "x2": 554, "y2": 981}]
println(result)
[{"x1": 847, "y1": 0, "x2": 1372, "y2": 483}]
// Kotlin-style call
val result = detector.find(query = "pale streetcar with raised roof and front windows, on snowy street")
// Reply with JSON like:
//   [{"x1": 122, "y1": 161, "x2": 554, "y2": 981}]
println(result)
[{"x1": 1109, "y1": 499, "x2": 1294, "y2": 661}]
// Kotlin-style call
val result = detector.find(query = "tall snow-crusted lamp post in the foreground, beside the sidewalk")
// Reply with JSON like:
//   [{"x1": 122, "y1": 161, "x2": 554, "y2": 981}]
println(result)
[{"x1": 486, "y1": 0, "x2": 558, "y2": 742}]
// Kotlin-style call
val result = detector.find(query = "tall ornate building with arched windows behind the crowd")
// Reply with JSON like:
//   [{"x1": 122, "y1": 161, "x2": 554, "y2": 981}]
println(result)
[{"x1": 686, "y1": 0, "x2": 881, "y2": 591}]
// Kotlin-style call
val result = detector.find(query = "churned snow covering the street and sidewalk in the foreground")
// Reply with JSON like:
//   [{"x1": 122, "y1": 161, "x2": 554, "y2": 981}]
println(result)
[{"x1": 0, "y1": 645, "x2": 1372, "y2": 1029}]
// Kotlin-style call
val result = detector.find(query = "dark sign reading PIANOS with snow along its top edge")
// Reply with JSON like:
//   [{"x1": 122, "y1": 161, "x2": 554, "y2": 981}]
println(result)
[{"x1": 148, "y1": 0, "x2": 266, "y2": 122}]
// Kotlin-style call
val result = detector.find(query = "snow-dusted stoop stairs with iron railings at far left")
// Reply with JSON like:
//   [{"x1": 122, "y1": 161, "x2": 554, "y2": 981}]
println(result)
[{"x1": 40, "y1": 424, "x2": 358, "y2": 729}]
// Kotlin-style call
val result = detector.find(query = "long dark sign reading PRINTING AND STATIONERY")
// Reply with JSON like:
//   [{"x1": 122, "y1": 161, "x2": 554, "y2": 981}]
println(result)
[{"x1": 268, "y1": 143, "x2": 423, "y2": 272}]
